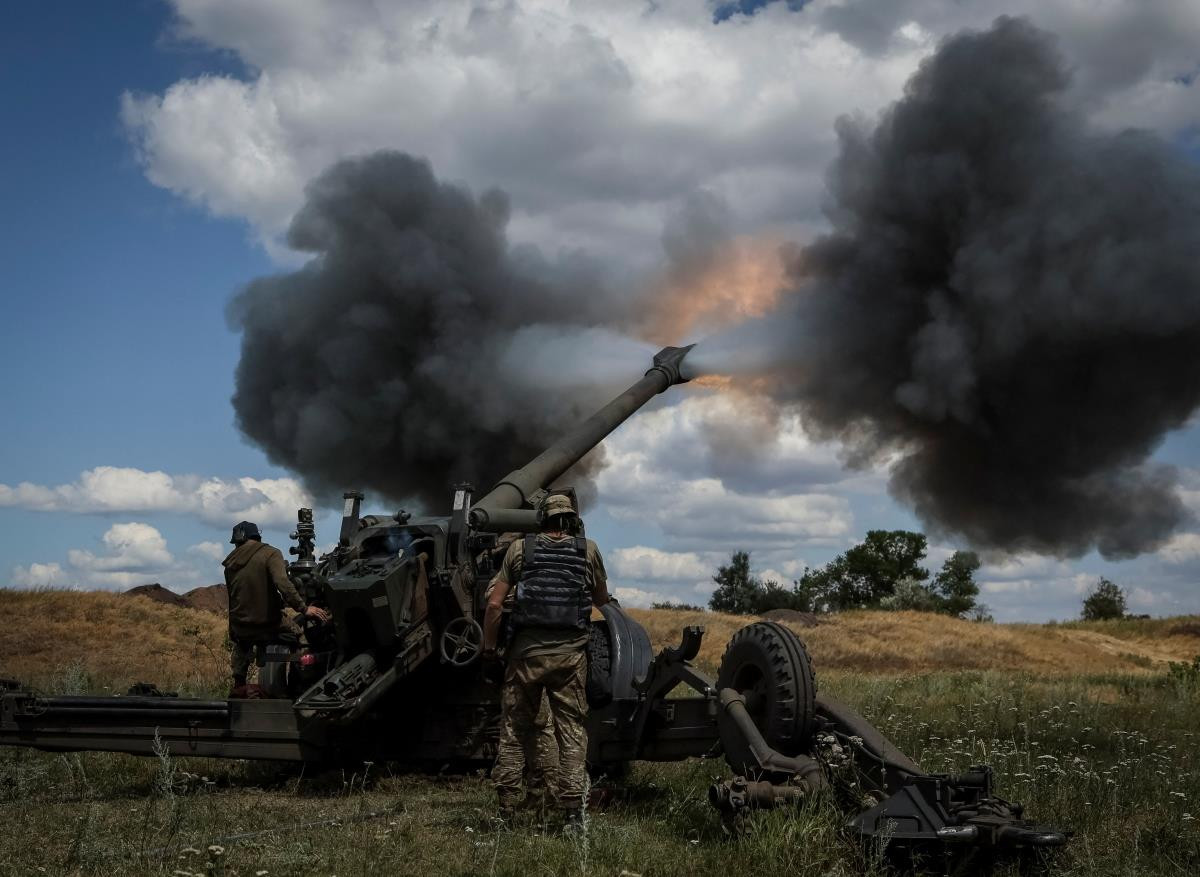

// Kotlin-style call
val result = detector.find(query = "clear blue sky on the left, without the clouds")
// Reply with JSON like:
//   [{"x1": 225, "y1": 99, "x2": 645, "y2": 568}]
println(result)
[{"x1": 0, "y1": 0, "x2": 290, "y2": 567}]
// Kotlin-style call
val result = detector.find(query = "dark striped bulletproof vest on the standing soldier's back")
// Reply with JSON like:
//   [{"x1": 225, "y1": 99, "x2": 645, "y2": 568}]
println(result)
[{"x1": 512, "y1": 536, "x2": 592, "y2": 630}]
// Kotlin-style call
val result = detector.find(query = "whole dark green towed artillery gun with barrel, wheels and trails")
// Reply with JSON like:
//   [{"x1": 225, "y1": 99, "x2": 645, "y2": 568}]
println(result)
[{"x1": 0, "y1": 347, "x2": 1066, "y2": 860}]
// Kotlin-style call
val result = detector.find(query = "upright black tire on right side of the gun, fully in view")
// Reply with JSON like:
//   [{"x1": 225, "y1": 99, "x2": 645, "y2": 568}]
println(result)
[{"x1": 716, "y1": 621, "x2": 817, "y2": 756}]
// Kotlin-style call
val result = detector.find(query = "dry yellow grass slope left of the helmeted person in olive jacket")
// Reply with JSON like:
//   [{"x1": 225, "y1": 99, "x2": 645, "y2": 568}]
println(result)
[{"x1": 0, "y1": 589, "x2": 229, "y2": 690}]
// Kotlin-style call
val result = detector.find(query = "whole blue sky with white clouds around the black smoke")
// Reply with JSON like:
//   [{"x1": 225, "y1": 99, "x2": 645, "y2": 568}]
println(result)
[{"x1": 0, "y1": 0, "x2": 1200, "y2": 619}]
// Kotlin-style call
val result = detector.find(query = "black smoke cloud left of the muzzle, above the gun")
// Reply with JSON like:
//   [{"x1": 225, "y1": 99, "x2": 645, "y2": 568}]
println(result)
[{"x1": 229, "y1": 152, "x2": 648, "y2": 510}]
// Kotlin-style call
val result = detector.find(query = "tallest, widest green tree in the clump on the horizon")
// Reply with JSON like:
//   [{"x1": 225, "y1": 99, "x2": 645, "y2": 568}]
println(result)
[{"x1": 797, "y1": 530, "x2": 929, "y2": 612}]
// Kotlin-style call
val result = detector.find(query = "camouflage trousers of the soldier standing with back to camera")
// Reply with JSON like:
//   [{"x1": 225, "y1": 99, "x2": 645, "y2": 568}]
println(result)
[{"x1": 492, "y1": 651, "x2": 588, "y2": 810}]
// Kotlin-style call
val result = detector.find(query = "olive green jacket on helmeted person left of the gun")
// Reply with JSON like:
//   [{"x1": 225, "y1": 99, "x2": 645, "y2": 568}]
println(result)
[{"x1": 222, "y1": 539, "x2": 305, "y2": 639}]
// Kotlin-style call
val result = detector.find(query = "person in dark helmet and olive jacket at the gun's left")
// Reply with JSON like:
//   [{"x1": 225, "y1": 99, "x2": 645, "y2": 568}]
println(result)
[{"x1": 222, "y1": 521, "x2": 329, "y2": 697}]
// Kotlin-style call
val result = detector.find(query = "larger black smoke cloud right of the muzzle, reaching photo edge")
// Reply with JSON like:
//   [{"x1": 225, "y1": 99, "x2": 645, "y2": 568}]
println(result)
[{"x1": 743, "y1": 18, "x2": 1200, "y2": 558}]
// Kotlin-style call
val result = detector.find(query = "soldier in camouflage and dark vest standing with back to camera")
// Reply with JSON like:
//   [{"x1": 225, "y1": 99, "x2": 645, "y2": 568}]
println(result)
[{"x1": 484, "y1": 494, "x2": 608, "y2": 827}]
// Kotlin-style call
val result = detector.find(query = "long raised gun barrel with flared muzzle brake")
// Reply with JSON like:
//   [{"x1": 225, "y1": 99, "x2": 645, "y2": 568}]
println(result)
[{"x1": 470, "y1": 344, "x2": 695, "y2": 533}]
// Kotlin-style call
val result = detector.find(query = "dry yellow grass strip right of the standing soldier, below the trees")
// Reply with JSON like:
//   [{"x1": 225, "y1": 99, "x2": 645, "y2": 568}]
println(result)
[{"x1": 630, "y1": 609, "x2": 1200, "y2": 675}]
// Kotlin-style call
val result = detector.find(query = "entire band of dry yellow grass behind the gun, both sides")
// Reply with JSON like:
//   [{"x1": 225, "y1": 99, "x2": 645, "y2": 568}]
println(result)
[{"x1": 0, "y1": 589, "x2": 1200, "y2": 690}]
